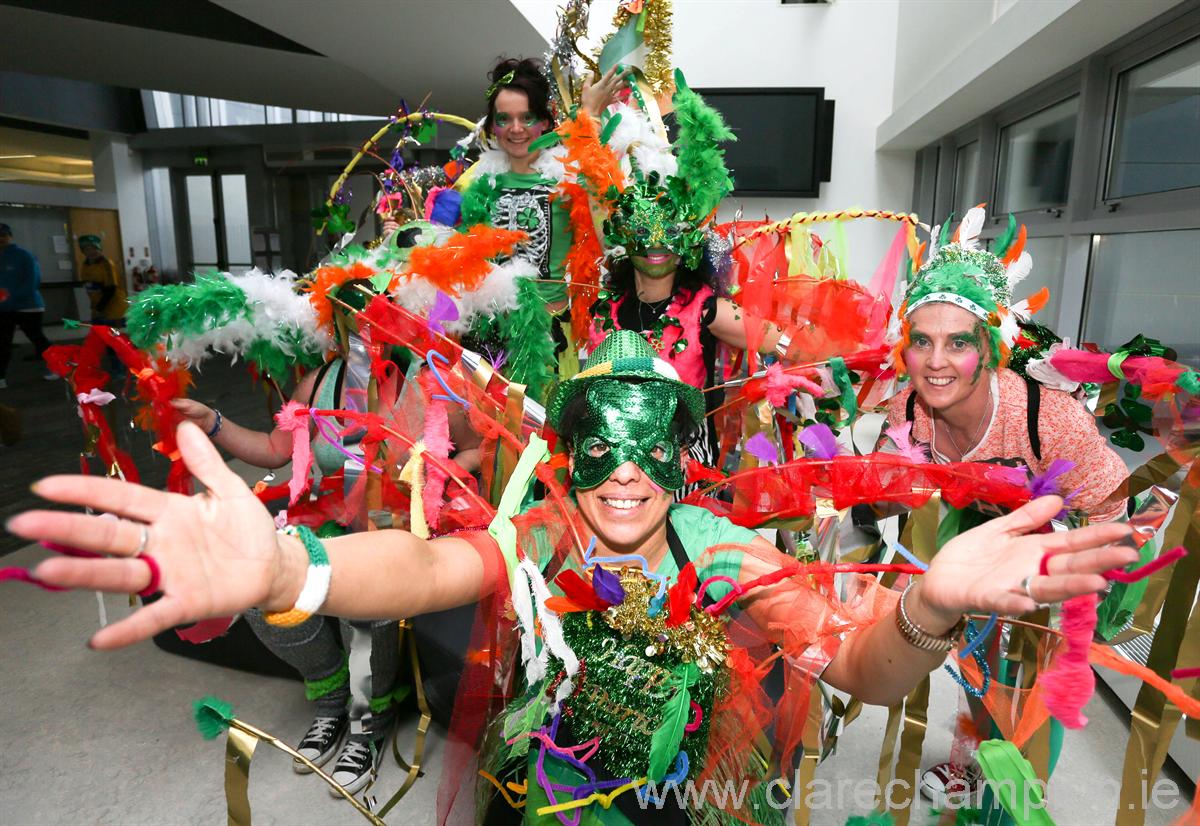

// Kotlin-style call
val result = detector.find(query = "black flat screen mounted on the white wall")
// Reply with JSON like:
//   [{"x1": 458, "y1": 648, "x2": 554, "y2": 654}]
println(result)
[{"x1": 696, "y1": 88, "x2": 834, "y2": 198}]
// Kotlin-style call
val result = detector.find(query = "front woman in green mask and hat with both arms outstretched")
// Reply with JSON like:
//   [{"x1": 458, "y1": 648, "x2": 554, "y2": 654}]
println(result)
[{"x1": 8, "y1": 333, "x2": 1136, "y2": 824}]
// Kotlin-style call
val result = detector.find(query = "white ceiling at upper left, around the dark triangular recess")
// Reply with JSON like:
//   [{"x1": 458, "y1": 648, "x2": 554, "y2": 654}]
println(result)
[{"x1": 0, "y1": 0, "x2": 546, "y2": 118}]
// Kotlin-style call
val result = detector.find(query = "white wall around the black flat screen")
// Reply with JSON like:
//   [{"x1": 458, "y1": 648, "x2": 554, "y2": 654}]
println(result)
[{"x1": 512, "y1": 0, "x2": 912, "y2": 280}]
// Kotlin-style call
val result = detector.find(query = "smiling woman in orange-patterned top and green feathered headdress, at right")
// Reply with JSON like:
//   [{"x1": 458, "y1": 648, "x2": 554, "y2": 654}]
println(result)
[{"x1": 883, "y1": 208, "x2": 1128, "y2": 806}]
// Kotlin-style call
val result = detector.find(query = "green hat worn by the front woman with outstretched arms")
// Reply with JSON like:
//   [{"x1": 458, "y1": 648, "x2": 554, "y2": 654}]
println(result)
[{"x1": 546, "y1": 330, "x2": 704, "y2": 429}]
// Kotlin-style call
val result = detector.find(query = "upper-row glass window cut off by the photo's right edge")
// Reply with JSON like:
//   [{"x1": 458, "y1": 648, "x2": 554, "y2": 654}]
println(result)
[{"x1": 1105, "y1": 40, "x2": 1200, "y2": 198}]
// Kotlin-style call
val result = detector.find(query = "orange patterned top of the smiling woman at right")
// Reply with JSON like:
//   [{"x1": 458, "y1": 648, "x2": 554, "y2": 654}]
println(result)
[{"x1": 887, "y1": 369, "x2": 1129, "y2": 521}]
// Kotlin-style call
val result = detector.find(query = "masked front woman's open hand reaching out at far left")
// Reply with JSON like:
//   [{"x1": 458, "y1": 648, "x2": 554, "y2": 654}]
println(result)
[{"x1": 7, "y1": 421, "x2": 295, "y2": 648}]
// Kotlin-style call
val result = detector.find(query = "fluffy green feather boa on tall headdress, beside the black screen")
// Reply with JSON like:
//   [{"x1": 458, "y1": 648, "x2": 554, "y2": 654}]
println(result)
[{"x1": 671, "y1": 68, "x2": 737, "y2": 221}]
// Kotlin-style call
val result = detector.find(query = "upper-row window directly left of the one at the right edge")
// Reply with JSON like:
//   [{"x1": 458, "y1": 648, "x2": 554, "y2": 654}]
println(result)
[{"x1": 996, "y1": 96, "x2": 1079, "y2": 213}]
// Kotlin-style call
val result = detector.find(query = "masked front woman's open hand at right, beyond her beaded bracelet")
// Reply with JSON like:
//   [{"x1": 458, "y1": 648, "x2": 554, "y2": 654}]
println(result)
[{"x1": 908, "y1": 496, "x2": 1138, "y2": 633}]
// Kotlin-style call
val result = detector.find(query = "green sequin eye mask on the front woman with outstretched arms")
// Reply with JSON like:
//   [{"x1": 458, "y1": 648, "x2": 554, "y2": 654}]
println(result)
[{"x1": 571, "y1": 379, "x2": 683, "y2": 491}]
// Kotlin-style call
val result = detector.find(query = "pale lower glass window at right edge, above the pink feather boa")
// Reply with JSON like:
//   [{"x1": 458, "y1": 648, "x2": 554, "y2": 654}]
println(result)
[{"x1": 1084, "y1": 229, "x2": 1200, "y2": 370}]
